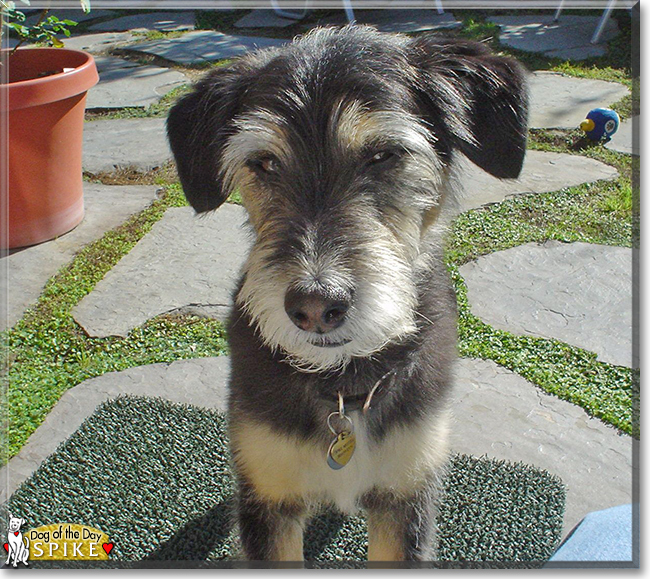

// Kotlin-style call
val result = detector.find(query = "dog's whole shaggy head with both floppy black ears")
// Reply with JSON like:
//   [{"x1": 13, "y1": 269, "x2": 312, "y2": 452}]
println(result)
[{"x1": 168, "y1": 26, "x2": 527, "y2": 370}]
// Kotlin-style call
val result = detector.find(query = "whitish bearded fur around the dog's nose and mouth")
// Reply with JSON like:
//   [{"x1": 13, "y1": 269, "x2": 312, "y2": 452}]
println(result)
[{"x1": 237, "y1": 239, "x2": 417, "y2": 372}]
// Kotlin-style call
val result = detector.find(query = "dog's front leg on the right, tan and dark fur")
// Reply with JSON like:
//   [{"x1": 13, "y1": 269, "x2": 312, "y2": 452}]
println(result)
[{"x1": 364, "y1": 488, "x2": 437, "y2": 561}]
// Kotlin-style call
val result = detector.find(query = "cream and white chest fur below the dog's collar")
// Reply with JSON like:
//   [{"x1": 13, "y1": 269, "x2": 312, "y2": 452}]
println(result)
[{"x1": 231, "y1": 412, "x2": 448, "y2": 512}]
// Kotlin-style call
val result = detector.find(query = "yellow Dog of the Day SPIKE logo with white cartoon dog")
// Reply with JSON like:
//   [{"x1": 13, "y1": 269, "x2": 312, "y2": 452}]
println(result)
[{"x1": 4, "y1": 515, "x2": 114, "y2": 567}]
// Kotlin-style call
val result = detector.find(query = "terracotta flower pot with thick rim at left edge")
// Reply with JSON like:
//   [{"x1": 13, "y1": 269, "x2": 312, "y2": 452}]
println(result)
[{"x1": 0, "y1": 48, "x2": 99, "y2": 249}]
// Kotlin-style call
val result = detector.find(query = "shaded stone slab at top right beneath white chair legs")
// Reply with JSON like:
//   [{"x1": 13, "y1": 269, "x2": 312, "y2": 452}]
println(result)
[{"x1": 488, "y1": 14, "x2": 618, "y2": 60}]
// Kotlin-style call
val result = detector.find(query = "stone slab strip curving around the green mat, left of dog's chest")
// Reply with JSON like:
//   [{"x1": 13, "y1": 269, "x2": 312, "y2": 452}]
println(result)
[{"x1": 0, "y1": 356, "x2": 230, "y2": 502}]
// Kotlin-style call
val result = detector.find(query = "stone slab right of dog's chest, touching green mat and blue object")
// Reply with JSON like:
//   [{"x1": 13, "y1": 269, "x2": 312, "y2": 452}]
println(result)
[{"x1": 451, "y1": 359, "x2": 638, "y2": 535}]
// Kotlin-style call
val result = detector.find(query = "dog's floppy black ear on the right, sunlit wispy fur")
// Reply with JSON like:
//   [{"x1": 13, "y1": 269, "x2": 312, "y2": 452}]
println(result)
[{"x1": 413, "y1": 36, "x2": 528, "y2": 178}]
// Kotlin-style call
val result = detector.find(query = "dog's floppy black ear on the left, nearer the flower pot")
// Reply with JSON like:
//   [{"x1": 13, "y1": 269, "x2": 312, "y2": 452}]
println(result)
[{"x1": 167, "y1": 63, "x2": 247, "y2": 213}]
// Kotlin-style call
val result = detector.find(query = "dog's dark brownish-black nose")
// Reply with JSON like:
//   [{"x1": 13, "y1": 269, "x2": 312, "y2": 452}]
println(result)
[{"x1": 284, "y1": 288, "x2": 352, "y2": 334}]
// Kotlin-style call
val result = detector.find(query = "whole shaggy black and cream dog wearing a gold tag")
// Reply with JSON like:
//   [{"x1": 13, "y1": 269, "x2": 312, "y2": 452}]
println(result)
[{"x1": 167, "y1": 25, "x2": 527, "y2": 561}]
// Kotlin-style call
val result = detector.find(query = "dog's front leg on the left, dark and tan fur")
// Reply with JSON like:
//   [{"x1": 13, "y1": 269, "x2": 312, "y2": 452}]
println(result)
[{"x1": 237, "y1": 482, "x2": 305, "y2": 561}]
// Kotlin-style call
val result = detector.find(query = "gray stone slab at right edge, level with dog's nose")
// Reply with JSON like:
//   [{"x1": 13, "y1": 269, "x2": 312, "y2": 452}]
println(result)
[{"x1": 460, "y1": 241, "x2": 636, "y2": 367}]
